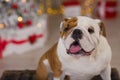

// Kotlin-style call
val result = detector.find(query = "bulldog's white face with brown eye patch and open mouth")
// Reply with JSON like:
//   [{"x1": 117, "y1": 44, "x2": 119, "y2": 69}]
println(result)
[{"x1": 60, "y1": 16, "x2": 105, "y2": 55}]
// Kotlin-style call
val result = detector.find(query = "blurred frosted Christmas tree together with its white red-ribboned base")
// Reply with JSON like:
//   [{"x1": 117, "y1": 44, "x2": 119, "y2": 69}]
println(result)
[{"x1": 0, "y1": 0, "x2": 47, "y2": 58}]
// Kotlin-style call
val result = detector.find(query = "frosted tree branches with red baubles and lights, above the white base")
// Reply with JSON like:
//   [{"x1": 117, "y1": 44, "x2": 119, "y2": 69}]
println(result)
[{"x1": 0, "y1": 0, "x2": 43, "y2": 29}]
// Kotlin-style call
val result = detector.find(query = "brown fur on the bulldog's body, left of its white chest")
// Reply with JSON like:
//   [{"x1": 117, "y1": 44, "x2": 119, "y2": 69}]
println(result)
[{"x1": 36, "y1": 43, "x2": 62, "y2": 80}]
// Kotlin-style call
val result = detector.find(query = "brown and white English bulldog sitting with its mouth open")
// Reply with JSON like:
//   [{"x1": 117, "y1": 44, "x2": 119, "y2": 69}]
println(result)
[{"x1": 36, "y1": 16, "x2": 111, "y2": 80}]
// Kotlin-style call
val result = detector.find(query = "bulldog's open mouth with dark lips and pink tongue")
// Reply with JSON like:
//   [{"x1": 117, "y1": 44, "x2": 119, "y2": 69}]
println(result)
[{"x1": 67, "y1": 41, "x2": 94, "y2": 55}]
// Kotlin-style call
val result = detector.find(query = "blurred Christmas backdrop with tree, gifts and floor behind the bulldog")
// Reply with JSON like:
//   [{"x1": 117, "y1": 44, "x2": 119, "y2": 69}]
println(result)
[{"x1": 0, "y1": 0, "x2": 120, "y2": 76}]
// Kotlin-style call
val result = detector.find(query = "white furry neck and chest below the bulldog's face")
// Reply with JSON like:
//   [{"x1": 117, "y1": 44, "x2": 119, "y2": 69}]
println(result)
[{"x1": 58, "y1": 37, "x2": 111, "y2": 80}]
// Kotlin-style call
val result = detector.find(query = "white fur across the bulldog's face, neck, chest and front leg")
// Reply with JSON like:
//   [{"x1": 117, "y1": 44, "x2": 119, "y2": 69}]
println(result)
[{"x1": 57, "y1": 17, "x2": 111, "y2": 80}]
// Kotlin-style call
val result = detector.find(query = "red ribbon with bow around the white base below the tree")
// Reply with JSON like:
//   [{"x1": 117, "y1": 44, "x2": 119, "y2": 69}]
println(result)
[{"x1": 0, "y1": 34, "x2": 43, "y2": 58}]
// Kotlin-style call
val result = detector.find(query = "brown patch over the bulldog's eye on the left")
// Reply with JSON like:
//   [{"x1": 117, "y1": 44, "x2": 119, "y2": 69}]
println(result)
[{"x1": 61, "y1": 17, "x2": 78, "y2": 39}]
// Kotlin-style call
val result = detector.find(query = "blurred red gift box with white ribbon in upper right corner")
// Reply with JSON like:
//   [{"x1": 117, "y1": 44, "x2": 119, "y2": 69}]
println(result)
[{"x1": 98, "y1": 1, "x2": 117, "y2": 18}]
